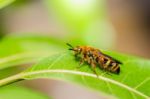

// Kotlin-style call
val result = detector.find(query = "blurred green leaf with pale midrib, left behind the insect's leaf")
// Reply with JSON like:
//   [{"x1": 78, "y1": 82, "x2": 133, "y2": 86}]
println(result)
[{"x1": 0, "y1": 35, "x2": 65, "y2": 69}]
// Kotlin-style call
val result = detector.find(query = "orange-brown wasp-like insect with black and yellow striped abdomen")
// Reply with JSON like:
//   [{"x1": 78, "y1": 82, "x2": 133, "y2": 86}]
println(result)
[{"x1": 67, "y1": 43, "x2": 122, "y2": 75}]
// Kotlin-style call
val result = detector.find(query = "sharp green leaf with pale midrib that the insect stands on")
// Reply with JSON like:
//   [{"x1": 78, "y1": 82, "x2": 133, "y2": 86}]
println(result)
[{"x1": 0, "y1": 52, "x2": 150, "y2": 99}]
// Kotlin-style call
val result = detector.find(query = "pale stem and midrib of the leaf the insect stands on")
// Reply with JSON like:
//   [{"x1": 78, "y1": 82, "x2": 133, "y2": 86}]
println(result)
[{"x1": 0, "y1": 70, "x2": 150, "y2": 99}]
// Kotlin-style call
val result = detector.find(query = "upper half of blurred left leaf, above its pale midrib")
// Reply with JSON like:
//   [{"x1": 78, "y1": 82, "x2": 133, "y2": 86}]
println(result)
[{"x1": 0, "y1": 34, "x2": 65, "y2": 57}]
